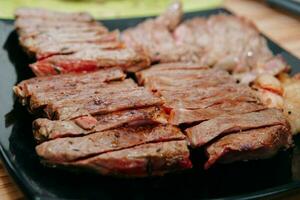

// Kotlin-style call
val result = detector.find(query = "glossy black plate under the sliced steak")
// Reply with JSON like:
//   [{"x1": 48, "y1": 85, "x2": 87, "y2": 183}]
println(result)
[{"x1": 0, "y1": 9, "x2": 300, "y2": 199}]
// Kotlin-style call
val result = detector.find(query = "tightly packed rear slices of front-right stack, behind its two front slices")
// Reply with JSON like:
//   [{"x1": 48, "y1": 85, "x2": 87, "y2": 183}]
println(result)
[{"x1": 137, "y1": 63, "x2": 263, "y2": 118}]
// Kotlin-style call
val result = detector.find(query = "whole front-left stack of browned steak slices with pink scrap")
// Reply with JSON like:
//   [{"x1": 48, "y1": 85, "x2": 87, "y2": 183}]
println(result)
[{"x1": 14, "y1": 68, "x2": 192, "y2": 176}]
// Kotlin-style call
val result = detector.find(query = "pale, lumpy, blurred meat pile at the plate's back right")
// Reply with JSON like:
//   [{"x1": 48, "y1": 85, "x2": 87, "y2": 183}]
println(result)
[{"x1": 122, "y1": 2, "x2": 288, "y2": 83}]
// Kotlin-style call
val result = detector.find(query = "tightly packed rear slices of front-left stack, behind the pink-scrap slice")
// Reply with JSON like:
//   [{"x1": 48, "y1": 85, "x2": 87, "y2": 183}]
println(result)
[{"x1": 14, "y1": 68, "x2": 163, "y2": 120}]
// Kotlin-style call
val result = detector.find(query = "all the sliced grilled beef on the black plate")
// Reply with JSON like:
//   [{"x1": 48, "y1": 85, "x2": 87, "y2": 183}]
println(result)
[{"x1": 14, "y1": 2, "x2": 292, "y2": 176}]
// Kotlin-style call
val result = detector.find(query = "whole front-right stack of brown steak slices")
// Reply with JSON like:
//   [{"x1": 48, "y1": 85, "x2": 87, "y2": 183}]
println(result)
[{"x1": 137, "y1": 63, "x2": 292, "y2": 168}]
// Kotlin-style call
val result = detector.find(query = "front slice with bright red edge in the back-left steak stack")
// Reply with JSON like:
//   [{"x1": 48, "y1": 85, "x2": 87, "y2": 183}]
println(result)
[{"x1": 30, "y1": 49, "x2": 150, "y2": 76}]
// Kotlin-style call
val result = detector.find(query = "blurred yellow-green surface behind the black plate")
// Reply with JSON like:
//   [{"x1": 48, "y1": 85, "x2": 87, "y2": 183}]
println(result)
[{"x1": 0, "y1": 0, "x2": 222, "y2": 19}]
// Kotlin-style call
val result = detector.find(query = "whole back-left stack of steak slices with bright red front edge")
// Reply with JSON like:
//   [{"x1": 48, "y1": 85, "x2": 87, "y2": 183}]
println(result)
[{"x1": 15, "y1": 8, "x2": 149, "y2": 76}]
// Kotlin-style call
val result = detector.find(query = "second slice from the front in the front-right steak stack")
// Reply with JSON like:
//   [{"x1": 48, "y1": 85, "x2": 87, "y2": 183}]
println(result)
[{"x1": 186, "y1": 109, "x2": 288, "y2": 147}]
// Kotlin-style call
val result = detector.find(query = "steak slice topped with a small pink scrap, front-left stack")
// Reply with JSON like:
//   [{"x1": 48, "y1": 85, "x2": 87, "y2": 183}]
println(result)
[{"x1": 32, "y1": 107, "x2": 167, "y2": 142}]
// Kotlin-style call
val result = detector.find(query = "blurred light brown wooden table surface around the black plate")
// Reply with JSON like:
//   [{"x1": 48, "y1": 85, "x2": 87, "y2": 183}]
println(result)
[{"x1": 0, "y1": 0, "x2": 300, "y2": 200}]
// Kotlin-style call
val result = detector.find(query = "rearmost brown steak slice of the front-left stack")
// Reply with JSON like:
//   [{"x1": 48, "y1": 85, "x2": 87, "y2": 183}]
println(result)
[{"x1": 13, "y1": 67, "x2": 126, "y2": 103}]
